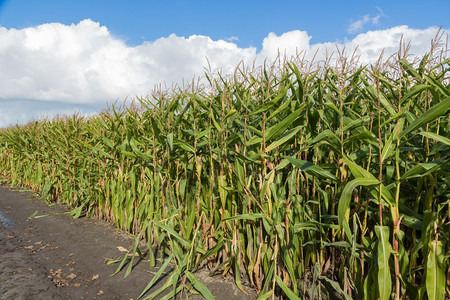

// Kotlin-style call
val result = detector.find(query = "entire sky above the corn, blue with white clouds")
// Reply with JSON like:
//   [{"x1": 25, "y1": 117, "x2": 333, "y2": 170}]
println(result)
[{"x1": 0, "y1": 0, "x2": 450, "y2": 127}]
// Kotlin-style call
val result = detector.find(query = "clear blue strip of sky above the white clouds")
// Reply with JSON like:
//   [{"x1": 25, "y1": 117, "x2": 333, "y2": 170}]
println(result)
[{"x1": 0, "y1": 0, "x2": 450, "y2": 48}]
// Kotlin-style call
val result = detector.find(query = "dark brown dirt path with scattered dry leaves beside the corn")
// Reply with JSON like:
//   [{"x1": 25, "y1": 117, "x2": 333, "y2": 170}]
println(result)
[{"x1": 0, "y1": 186, "x2": 256, "y2": 300}]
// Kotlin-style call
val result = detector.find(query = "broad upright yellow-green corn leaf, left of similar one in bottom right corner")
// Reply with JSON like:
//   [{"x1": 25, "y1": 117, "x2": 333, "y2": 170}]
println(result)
[{"x1": 375, "y1": 225, "x2": 392, "y2": 300}]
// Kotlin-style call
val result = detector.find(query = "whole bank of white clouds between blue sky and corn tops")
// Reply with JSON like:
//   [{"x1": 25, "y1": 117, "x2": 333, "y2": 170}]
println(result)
[{"x1": 0, "y1": 20, "x2": 449, "y2": 127}]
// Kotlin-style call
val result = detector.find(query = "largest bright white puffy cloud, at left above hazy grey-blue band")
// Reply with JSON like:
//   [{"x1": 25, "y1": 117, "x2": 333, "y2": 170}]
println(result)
[{"x1": 0, "y1": 20, "x2": 256, "y2": 103}]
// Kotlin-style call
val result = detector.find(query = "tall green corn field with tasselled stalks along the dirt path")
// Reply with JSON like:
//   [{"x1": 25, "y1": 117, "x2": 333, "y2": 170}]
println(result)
[{"x1": 0, "y1": 43, "x2": 450, "y2": 300}]
